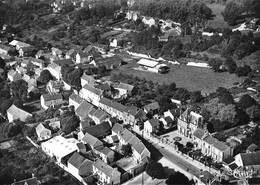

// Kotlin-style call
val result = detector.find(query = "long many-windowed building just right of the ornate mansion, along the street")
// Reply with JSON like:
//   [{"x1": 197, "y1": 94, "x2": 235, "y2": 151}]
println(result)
[{"x1": 192, "y1": 128, "x2": 233, "y2": 162}]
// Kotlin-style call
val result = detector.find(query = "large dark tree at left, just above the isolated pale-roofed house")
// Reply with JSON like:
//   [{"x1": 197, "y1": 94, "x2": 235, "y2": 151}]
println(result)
[{"x1": 10, "y1": 79, "x2": 28, "y2": 100}]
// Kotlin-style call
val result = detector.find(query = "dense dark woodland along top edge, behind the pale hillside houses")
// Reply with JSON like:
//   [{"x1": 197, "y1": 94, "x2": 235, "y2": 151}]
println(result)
[{"x1": 132, "y1": 0, "x2": 212, "y2": 23}]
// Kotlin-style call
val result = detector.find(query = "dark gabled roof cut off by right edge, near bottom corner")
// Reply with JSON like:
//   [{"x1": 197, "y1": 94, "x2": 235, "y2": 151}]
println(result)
[{"x1": 238, "y1": 151, "x2": 260, "y2": 166}]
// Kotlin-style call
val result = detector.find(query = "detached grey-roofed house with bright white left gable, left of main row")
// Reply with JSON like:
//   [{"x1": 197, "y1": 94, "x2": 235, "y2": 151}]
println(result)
[{"x1": 41, "y1": 94, "x2": 63, "y2": 109}]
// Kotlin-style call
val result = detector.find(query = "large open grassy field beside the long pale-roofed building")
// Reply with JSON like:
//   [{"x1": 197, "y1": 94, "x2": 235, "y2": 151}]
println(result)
[{"x1": 112, "y1": 65, "x2": 242, "y2": 94}]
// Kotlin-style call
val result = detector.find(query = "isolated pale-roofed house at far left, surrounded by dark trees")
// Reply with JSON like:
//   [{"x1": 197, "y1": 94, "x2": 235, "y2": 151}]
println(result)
[{"x1": 6, "y1": 105, "x2": 32, "y2": 123}]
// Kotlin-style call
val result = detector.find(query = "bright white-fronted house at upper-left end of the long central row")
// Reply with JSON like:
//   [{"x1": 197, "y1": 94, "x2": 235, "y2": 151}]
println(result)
[{"x1": 79, "y1": 84, "x2": 103, "y2": 106}]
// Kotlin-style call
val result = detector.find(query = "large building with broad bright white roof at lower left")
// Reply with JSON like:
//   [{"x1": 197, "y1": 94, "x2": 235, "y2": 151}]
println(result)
[{"x1": 41, "y1": 136, "x2": 79, "y2": 163}]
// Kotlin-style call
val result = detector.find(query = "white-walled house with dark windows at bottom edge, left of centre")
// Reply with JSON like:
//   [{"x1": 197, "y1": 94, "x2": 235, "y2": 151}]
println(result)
[{"x1": 93, "y1": 159, "x2": 121, "y2": 184}]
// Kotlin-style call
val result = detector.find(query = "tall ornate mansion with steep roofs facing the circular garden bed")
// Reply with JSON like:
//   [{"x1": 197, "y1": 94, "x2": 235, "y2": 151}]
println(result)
[{"x1": 177, "y1": 109, "x2": 203, "y2": 138}]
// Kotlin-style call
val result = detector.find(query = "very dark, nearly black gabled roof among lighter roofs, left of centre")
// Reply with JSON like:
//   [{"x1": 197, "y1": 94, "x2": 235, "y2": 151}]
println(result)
[{"x1": 85, "y1": 122, "x2": 111, "y2": 138}]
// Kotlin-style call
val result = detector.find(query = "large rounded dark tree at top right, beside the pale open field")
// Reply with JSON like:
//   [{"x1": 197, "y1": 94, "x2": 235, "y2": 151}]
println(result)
[{"x1": 222, "y1": 1, "x2": 241, "y2": 25}]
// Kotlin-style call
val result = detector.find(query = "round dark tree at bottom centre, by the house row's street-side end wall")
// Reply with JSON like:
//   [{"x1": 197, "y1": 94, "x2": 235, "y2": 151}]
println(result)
[{"x1": 145, "y1": 161, "x2": 164, "y2": 179}]
